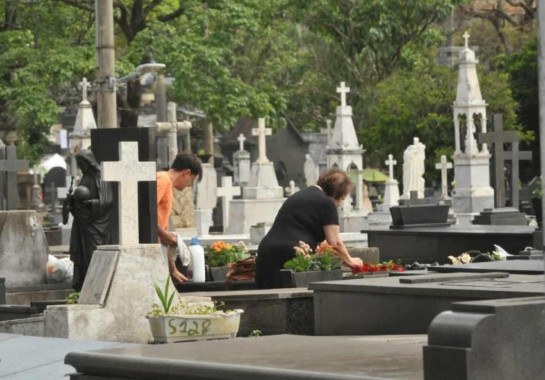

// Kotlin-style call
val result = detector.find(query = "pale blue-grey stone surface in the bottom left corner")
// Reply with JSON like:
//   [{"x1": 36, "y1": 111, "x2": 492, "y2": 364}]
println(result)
[{"x1": 0, "y1": 333, "x2": 131, "y2": 380}]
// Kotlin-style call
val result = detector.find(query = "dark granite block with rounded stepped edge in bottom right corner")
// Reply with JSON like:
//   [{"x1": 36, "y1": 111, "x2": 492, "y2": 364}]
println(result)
[{"x1": 424, "y1": 297, "x2": 545, "y2": 380}]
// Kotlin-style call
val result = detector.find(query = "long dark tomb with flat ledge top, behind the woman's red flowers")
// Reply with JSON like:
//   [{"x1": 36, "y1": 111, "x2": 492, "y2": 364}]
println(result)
[{"x1": 362, "y1": 225, "x2": 535, "y2": 263}]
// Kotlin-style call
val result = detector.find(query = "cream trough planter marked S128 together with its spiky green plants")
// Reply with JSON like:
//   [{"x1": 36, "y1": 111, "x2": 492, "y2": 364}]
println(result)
[{"x1": 146, "y1": 277, "x2": 243, "y2": 343}]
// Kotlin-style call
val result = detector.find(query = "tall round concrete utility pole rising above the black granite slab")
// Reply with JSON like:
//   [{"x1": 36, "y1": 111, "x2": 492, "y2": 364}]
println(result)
[{"x1": 95, "y1": 0, "x2": 117, "y2": 128}]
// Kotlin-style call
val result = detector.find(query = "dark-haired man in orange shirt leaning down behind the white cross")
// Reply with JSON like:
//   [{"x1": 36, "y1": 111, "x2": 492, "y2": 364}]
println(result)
[{"x1": 157, "y1": 154, "x2": 202, "y2": 283}]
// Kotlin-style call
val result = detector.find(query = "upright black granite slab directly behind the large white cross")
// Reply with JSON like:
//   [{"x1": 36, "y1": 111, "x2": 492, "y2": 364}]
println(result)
[{"x1": 91, "y1": 128, "x2": 157, "y2": 244}]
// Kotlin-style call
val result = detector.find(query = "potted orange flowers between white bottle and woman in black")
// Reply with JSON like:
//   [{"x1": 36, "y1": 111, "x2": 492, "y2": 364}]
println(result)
[{"x1": 205, "y1": 240, "x2": 250, "y2": 281}]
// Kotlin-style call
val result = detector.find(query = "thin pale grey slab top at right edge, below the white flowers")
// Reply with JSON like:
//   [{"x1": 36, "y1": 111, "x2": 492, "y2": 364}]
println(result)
[{"x1": 428, "y1": 260, "x2": 545, "y2": 274}]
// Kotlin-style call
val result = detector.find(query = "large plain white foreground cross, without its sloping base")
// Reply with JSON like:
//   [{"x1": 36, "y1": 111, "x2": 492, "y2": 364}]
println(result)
[{"x1": 101, "y1": 141, "x2": 156, "y2": 245}]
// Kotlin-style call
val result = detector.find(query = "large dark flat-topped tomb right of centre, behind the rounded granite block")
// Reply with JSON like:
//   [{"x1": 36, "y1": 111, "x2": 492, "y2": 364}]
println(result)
[{"x1": 309, "y1": 273, "x2": 545, "y2": 335}]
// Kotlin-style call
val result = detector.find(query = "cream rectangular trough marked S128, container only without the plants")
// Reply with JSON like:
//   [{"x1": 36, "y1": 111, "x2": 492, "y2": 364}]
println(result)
[{"x1": 149, "y1": 309, "x2": 243, "y2": 343}]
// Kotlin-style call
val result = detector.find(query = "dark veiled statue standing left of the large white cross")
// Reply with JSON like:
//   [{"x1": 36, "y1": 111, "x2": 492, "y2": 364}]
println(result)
[{"x1": 63, "y1": 150, "x2": 113, "y2": 292}]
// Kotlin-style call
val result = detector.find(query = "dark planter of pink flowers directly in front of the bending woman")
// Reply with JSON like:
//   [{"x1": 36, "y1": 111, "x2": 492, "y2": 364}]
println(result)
[{"x1": 280, "y1": 241, "x2": 342, "y2": 288}]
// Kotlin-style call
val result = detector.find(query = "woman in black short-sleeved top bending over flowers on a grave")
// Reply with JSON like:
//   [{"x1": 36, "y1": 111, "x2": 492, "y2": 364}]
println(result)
[{"x1": 256, "y1": 169, "x2": 363, "y2": 289}]
